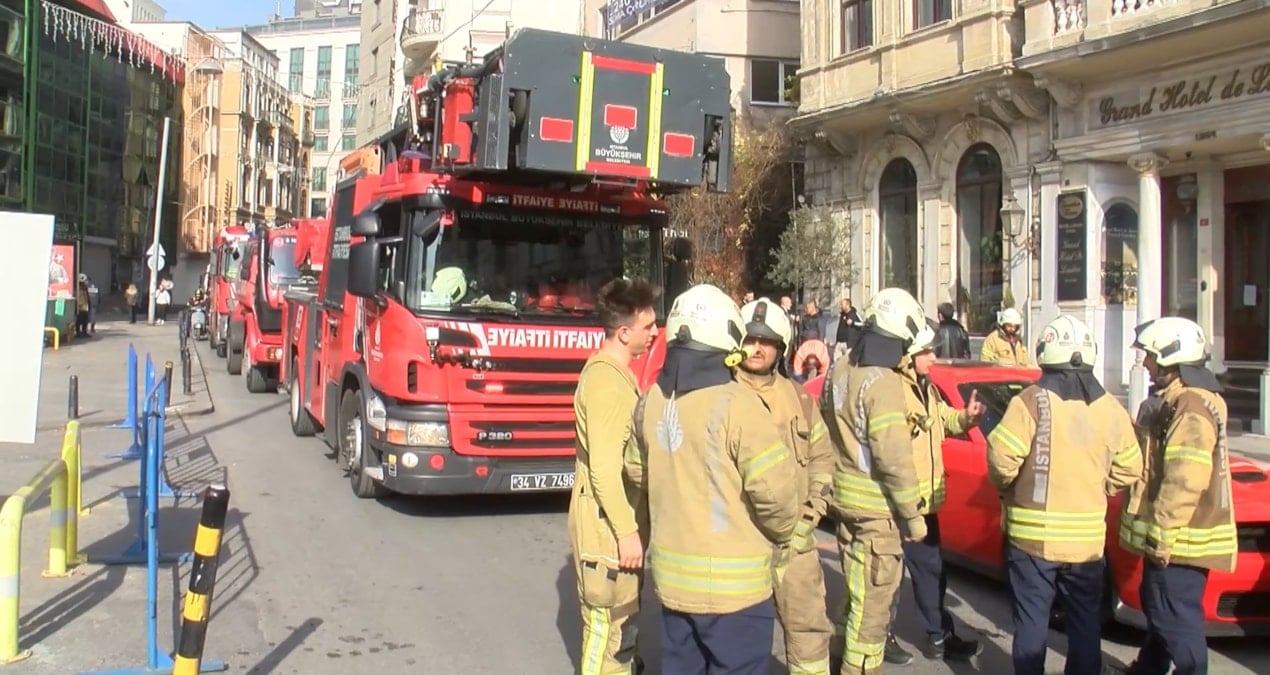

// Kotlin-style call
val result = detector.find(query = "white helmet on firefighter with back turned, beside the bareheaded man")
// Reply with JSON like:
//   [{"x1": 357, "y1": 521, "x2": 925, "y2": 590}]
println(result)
[{"x1": 665, "y1": 283, "x2": 745, "y2": 367}]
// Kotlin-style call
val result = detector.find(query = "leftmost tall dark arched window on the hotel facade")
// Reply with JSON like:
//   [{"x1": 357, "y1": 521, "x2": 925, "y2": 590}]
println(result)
[{"x1": 878, "y1": 159, "x2": 917, "y2": 295}]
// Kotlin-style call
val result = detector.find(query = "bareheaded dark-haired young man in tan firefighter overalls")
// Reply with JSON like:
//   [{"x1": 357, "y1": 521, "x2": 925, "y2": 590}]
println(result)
[{"x1": 569, "y1": 280, "x2": 658, "y2": 675}]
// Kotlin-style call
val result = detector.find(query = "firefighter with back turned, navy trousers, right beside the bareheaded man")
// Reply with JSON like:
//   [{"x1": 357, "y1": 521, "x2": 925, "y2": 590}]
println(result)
[{"x1": 626, "y1": 285, "x2": 806, "y2": 675}]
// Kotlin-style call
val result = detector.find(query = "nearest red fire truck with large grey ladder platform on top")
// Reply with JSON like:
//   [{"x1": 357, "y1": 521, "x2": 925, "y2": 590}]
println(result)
[{"x1": 283, "y1": 29, "x2": 732, "y2": 497}]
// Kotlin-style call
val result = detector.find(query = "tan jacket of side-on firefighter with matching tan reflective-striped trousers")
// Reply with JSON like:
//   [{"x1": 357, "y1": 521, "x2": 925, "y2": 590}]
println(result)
[{"x1": 820, "y1": 358, "x2": 930, "y2": 539}]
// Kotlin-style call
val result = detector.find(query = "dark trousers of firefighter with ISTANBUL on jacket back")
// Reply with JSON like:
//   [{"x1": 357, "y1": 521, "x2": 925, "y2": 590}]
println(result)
[{"x1": 1006, "y1": 547, "x2": 1104, "y2": 675}]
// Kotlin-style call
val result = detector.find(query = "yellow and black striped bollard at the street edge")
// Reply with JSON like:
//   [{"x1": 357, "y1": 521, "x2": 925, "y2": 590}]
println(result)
[{"x1": 171, "y1": 486, "x2": 230, "y2": 675}]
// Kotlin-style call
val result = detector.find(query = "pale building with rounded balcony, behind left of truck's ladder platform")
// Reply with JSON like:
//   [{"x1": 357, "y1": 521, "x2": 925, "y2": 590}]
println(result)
[{"x1": 357, "y1": 0, "x2": 585, "y2": 144}]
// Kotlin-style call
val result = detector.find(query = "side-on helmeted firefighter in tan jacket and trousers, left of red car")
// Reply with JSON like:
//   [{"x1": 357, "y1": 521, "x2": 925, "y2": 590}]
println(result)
[{"x1": 820, "y1": 289, "x2": 935, "y2": 674}]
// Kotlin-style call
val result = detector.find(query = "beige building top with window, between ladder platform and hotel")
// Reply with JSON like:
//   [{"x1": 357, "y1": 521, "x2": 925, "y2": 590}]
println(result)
[{"x1": 585, "y1": 0, "x2": 801, "y2": 127}]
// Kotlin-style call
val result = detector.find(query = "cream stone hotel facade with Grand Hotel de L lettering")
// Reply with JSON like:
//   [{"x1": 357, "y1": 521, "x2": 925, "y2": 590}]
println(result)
[{"x1": 792, "y1": 0, "x2": 1270, "y2": 429}]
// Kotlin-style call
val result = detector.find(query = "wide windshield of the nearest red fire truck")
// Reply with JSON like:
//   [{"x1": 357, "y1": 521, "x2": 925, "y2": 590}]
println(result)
[{"x1": 410, "y1": 208, "x2": 660, "y2": 320}]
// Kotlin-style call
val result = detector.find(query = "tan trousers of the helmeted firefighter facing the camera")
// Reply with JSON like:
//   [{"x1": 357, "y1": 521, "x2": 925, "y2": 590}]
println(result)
[{"x1": 773, "y1": 548, "x2": 833, "y2": 675}]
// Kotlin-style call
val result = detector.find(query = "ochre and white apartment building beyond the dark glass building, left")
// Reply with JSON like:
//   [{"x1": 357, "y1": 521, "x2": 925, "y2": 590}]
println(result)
[{"x1": 210, "y1": 29, "x2": 314, "y2": 233}]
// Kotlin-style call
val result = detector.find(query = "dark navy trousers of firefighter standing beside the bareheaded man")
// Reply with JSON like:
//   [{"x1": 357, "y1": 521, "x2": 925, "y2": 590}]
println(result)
[{"x1": 662, "y1": 599, "x2": 776, "y2": 675}]
